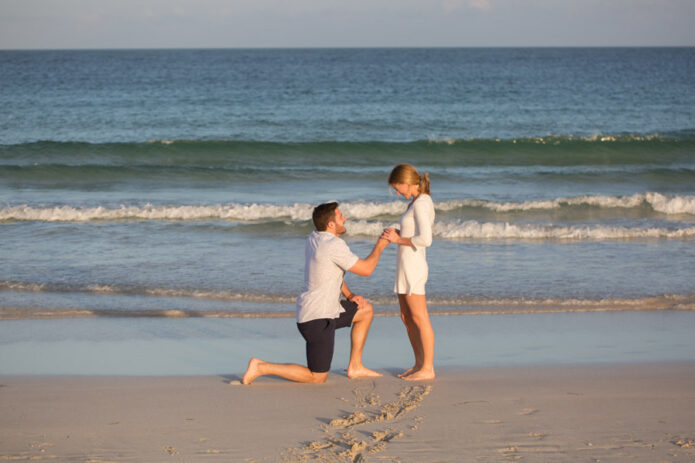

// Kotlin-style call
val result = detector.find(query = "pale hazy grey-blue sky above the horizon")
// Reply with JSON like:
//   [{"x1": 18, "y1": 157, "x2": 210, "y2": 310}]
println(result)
[{"x1": 0, "y1": 0, "x2": 695, "y2": 49}]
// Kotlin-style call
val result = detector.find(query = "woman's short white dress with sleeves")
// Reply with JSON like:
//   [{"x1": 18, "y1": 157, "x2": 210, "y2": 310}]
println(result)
[{"x1": 394, "y1": 194, "x2": 434, "y2": 295}]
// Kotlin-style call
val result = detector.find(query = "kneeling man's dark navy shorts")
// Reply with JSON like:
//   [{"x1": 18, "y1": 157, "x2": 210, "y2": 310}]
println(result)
[{"x1": 297, "y1": 301, "x2": 357, "y2": 373}]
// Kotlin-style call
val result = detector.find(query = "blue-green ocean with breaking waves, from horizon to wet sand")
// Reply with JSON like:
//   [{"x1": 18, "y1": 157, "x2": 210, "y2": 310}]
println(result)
[{"x1": 0, "y1": 48, "x2": 695, "y2": 372}]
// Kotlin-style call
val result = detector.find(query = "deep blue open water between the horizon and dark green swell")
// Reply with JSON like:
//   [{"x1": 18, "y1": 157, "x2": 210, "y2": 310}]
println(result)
[{"x1": 0, "y1": 48, "x2": 695, "y2": 144}]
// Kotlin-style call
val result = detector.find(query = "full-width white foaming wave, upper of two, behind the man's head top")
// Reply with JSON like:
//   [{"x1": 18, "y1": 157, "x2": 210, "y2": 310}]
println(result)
[{"x1": 0, "y1": 192, "x2": 695, "y2": 224}]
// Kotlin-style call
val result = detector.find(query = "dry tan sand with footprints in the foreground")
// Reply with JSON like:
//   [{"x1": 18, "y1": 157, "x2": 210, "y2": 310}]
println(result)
[{"x1": 0, "y1": 363, "x2": 695, "y2": 463}]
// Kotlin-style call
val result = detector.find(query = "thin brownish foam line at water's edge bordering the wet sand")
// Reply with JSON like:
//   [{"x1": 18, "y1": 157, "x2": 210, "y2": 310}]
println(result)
[{"x1": 0, "y1": 292, "x2": 695, "y2": 321}]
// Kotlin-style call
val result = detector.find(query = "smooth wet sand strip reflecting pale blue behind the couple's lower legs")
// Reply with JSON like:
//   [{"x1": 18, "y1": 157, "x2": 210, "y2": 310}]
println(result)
[{"x1": 0, "y1": 311, "x2": 695, "y2": 376}]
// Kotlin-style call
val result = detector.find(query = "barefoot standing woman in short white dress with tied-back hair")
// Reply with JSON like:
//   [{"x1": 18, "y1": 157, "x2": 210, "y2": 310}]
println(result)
[{"x1": 382, "y1": 164, "x2": 435, "y2": 381}]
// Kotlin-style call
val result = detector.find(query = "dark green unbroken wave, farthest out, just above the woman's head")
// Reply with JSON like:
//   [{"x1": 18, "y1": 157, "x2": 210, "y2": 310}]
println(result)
[{"x1": 0, "y1": 133, "x2": 695, "y2": 168}]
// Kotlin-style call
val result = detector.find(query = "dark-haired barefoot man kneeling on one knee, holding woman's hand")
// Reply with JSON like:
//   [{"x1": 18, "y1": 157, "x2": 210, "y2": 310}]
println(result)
[{"x1": 242, "y1": 203, "x2": 389, "y2": 384}]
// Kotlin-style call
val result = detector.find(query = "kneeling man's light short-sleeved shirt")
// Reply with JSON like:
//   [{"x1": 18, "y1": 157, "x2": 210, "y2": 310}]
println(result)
[{"x1": 297, "y1": 231, "x2": 359, "y2": 323}]
